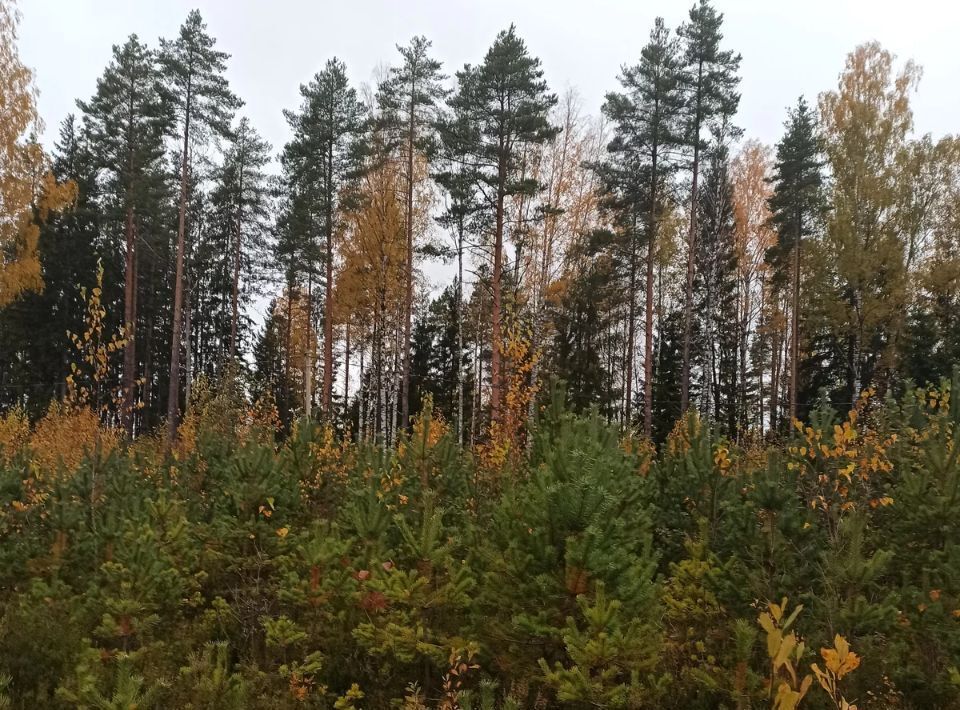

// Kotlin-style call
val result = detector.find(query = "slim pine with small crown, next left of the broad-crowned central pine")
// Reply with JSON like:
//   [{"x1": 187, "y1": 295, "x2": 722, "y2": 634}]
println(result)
[{"x1": 377, "y1": 36, "x2": 448, "y2": 428}]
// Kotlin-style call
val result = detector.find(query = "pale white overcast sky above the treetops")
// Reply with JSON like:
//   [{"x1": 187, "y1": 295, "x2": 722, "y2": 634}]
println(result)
[{"x1": 20, "y1": 0, "x2": 960, "y2": 159}]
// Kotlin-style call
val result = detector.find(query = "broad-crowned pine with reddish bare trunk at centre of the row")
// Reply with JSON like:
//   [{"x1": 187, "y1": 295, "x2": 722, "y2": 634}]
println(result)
[{"x1": 450, "y1": 25, "x2": 557, "y2": 422}]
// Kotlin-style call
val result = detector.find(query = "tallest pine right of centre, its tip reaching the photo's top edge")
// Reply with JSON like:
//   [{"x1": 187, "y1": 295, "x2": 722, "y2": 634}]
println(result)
[{"x1": 677, "y1": 0, "x2": 740, "y2": 411}]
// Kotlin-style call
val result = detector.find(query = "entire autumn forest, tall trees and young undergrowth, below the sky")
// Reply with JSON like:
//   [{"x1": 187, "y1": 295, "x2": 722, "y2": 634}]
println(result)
[{"x1": 0, "y1": 0, "x2": 960, "y2": 710}]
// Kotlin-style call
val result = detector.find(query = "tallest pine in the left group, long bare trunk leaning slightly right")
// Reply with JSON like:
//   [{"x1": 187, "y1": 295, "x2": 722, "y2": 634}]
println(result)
[{"x1": 160, "y1": 10, "x2": 240, "y2": 442}]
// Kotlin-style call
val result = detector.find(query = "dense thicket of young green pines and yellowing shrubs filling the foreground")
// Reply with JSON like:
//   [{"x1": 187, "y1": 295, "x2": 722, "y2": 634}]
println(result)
[{"x1": 0, "y1": 372, "x2": 960, "y2": 710}]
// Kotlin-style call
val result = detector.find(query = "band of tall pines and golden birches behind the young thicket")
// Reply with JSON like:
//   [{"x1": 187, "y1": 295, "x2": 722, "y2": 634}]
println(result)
[{"x1": 0, "y1": 1, "x2": 960, "y2": 443}]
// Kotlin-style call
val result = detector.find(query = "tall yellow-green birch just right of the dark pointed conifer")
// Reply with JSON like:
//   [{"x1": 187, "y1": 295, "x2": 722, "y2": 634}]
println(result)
[{"x1": 819, "y1": 42, "x2": 921, "y2": 377}]
